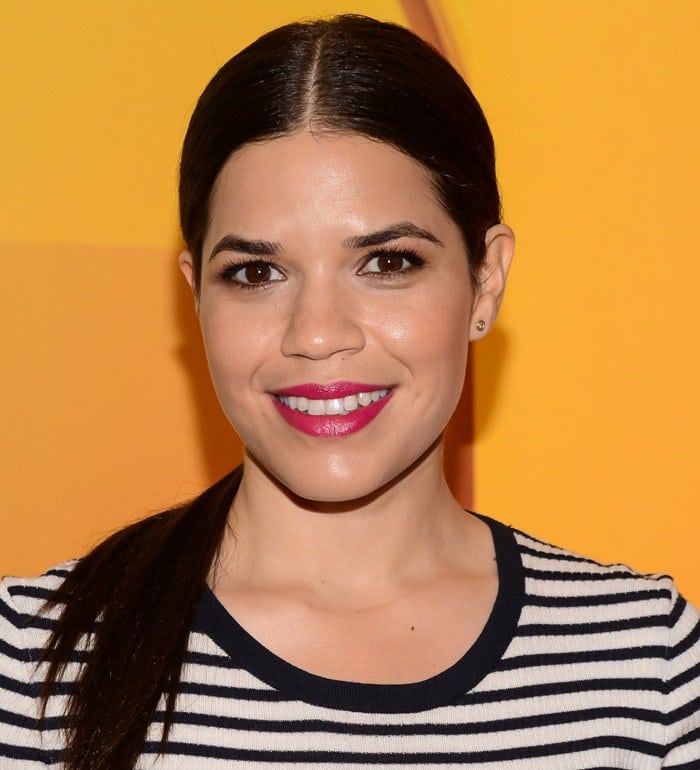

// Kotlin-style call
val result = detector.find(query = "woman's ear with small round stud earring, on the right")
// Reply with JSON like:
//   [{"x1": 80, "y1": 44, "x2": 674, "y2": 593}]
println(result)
[{"x1": 469, "y1": 224, "x2": 515, "y2": 340}]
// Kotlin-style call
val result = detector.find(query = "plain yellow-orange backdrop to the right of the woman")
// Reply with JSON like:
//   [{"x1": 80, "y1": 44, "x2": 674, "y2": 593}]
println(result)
[{"x1": 460, "y1": 0, "x2": 700, "y2": 604}]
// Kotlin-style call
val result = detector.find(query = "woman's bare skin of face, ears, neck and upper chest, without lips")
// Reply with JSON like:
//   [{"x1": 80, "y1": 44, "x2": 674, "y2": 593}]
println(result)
[{"x1": 180, "y1": 131, "x2": 513, "y2": 683}]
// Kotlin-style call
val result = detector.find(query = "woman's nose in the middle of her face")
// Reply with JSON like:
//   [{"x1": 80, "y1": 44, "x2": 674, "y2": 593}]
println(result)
[{"x1": 281, "y1": 279, "x2": 365, "y2": 360}]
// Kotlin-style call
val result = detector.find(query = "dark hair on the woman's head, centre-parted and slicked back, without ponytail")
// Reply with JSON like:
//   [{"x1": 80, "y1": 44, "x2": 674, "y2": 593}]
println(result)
[{"x1": 180, "y1": 16, "x2": 501, "y2": 283}]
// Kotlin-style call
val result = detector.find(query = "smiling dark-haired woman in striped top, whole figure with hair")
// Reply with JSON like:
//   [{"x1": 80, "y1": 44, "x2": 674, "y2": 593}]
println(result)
[{"x1": 0, "y1": 17, "x2": 700, "y2": 770}]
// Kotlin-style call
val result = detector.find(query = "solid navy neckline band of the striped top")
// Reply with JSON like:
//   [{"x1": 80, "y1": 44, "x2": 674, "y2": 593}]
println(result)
[{"x1": 195, "y1": 516, "x2": 524, "y2": 713}]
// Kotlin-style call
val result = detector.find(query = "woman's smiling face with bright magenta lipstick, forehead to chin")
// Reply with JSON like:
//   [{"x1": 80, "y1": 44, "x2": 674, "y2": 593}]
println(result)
[{"x1": 181, "y1": 132, "x2": 508, "y2": 501}]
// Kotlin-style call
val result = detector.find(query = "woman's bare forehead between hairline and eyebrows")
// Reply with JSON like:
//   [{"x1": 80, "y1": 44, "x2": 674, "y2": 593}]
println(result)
[{"x1": 210, "y1": 131, "x2": 446, "y2": 237}]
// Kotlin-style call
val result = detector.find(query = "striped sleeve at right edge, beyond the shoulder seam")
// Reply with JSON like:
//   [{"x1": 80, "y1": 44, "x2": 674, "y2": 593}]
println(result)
[{"x1": 663, "y1": 588, "x2": 700, "y2": 770}]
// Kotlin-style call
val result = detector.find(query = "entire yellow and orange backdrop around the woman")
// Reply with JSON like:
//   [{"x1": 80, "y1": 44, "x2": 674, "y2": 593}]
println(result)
[{"x1": 0, "y1": 0, "x2": 700, "y2": 603}]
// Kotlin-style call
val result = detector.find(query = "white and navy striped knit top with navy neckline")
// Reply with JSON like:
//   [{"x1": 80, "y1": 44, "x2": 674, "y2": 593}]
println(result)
[{"x1": 0, "y1": 519, "x2": 700, "y2": 770}]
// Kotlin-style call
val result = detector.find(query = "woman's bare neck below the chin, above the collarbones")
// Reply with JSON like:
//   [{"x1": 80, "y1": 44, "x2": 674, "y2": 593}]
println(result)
[{"x1": 217, "y1": 444, "x2": 474, "y2": 590}]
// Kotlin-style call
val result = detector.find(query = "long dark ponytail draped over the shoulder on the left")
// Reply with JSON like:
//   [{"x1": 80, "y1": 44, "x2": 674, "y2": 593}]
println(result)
[{"x1": 40, "y1": 466, "x2": 243, "y2": 770}]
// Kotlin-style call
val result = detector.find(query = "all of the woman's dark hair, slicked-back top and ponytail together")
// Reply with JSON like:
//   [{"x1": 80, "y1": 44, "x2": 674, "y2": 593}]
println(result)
[{"x1": 42, "y1": 16, "x2": 500, "y2": 770}]
